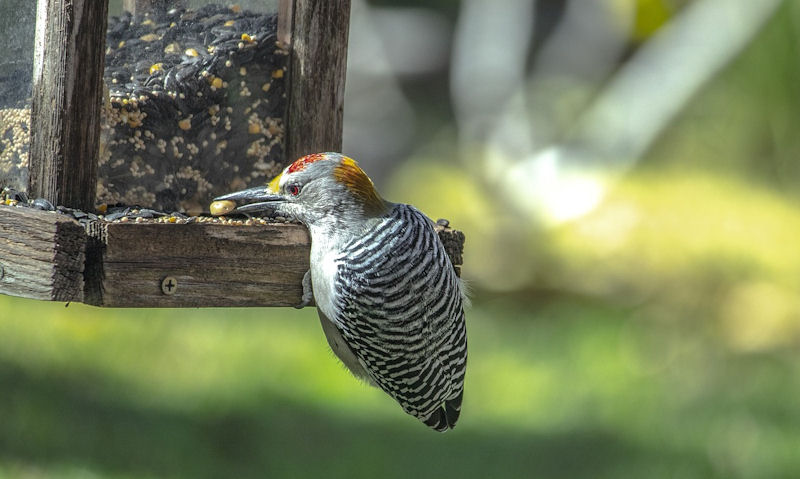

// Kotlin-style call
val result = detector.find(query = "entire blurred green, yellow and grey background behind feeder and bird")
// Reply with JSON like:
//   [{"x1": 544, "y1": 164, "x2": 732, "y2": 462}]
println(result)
[{"x1": 0, "y1": 0, "x2": 800, "y2": 478}]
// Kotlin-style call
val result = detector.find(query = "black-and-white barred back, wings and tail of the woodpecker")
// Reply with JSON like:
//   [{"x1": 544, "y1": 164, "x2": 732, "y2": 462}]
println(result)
[{"x1": 333, "y1": 205, "x2": 467, "y2": 431}]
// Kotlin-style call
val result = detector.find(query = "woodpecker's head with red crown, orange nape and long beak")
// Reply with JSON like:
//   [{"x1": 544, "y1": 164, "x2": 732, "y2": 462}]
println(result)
[{"x1": 212, "y1": 153, "x2": 388, "y2": 225}]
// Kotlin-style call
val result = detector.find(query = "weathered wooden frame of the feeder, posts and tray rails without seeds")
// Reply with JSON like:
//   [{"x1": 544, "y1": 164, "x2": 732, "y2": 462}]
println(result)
[{"x1": 0, "y1": 0, "x2": 463, "y2": 307}]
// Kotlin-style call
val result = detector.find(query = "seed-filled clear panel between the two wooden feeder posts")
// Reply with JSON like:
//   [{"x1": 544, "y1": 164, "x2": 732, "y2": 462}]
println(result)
[{"x1": 98, "y1": 0, "x2": 288, "y2": 213}]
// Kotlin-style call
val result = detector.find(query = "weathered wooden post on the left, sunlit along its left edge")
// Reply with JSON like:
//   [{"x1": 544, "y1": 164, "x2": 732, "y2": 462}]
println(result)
[{"x1": 29, "y1": 0, "x2": 108, "y2": 211}]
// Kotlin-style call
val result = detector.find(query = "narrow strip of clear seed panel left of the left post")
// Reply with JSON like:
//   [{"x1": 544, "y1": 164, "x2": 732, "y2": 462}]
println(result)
[{"x1": 0, "y1": 0, "x2": 36, "y2": 195}]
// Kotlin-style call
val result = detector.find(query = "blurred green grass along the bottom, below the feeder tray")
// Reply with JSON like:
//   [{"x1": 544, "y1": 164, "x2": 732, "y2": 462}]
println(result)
[{"x1": 0, "y1": 297, "x2": 800, "y2": 478}]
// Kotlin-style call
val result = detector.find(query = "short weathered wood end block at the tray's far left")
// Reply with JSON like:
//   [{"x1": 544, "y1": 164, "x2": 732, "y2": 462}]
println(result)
[{"x1": 0, "y1": 206, "x2": 86, "y2": 301}]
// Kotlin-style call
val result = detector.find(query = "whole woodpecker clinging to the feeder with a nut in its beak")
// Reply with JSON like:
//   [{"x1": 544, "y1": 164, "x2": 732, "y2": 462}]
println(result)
[{"x1": 212, "y1": 153, "x2": 467, "y2": 432}]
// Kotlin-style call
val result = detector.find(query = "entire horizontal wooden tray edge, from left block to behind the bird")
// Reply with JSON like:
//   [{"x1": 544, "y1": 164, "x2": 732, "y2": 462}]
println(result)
[{"x1": 0, "y1": 206, "x2": 464, "y2": 308}]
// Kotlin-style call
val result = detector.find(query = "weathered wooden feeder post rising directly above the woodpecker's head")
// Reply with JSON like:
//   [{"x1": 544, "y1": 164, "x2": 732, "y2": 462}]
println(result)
[{"x1": 278, "y1": 0, "x2": 350, "y2": 161}]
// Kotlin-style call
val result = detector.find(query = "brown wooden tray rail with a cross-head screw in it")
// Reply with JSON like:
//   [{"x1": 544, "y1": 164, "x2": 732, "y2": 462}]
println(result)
[{"x1": 85, "y1": 222, "x2": 310, "y2": 307}]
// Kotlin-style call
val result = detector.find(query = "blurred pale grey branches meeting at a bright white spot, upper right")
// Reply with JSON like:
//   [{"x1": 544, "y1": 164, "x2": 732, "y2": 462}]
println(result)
[{"x1": 452, "y1": 0, "x2": 781, "y2": 221}]
